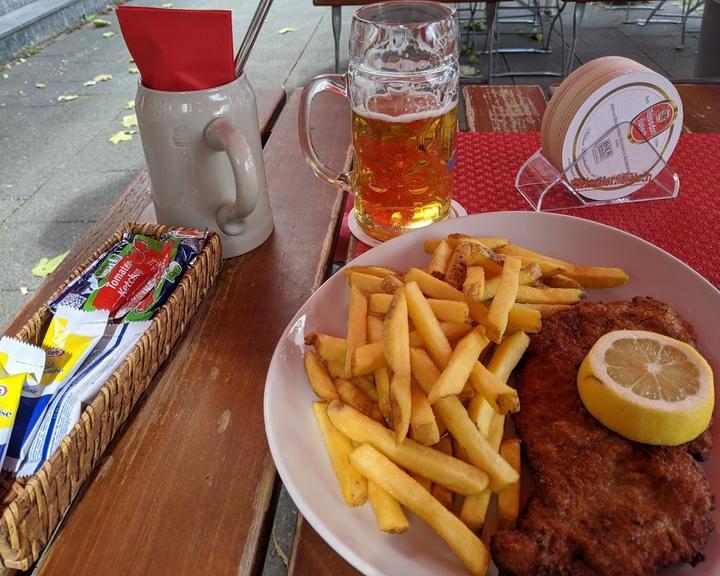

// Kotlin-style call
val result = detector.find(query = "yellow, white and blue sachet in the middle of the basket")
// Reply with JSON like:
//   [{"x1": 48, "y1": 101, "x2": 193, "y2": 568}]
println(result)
[{"x1": 3, "y1": 306, "x2": 108, "y2": 472}]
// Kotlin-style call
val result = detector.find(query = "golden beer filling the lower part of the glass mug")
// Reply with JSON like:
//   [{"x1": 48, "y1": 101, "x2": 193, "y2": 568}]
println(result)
[{"x1": 351, "y1": 96, "x2": 457, "y2": 240}]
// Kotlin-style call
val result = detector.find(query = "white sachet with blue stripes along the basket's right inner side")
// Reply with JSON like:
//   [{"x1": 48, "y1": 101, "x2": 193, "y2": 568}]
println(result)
[{"x1": 17, "y1": 320, "x2": 151, "y2": 476}]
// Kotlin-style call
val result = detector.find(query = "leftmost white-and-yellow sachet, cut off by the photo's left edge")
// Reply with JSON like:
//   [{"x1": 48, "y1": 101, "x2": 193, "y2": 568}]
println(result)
[{"x1": 0, "y1": 337, "x2": 45, "y2": 463}]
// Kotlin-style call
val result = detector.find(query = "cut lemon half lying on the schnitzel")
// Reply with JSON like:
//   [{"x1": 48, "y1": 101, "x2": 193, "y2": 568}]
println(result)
[{"x1": 577, "y1": 330, "x2": 715, "y2": 446}]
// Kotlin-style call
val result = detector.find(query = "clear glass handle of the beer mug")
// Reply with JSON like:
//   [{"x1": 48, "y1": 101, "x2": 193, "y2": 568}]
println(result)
[{"x1": 298, "y1": 74, "x2": 350, "y2": 190}]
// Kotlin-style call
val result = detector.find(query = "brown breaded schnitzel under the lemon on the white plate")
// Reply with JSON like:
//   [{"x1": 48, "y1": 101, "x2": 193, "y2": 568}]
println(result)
[{"x1": 492, "y1": 298, "x2": 714, "y2": 576}]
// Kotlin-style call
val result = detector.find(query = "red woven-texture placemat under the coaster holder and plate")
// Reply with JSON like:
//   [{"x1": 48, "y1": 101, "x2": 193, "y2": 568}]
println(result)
[{"x1": 343, "y1": 132, "x2": 720, "y2": 286}]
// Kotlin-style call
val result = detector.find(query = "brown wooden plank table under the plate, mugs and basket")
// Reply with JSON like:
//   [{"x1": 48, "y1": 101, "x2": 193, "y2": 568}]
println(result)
[{"x1": 1, "y1": 86, "x2": 720, "y2": 576}]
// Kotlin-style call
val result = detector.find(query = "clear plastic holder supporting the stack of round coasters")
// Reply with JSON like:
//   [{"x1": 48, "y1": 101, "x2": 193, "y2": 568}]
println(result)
[{"x1": 515, "y1": 122, "x2": 680, "y2": 212}]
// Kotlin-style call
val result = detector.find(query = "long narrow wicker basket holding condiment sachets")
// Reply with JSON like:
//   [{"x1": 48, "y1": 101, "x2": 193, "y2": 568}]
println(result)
[{"x1": 0, "y1": 223, "x2": 221, "y2": 570}]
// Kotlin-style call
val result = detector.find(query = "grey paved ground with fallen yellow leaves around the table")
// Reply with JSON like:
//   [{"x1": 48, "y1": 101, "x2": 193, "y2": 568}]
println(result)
[{"x1": 0, "y1": 0, "x2": 699, "y2": 575}]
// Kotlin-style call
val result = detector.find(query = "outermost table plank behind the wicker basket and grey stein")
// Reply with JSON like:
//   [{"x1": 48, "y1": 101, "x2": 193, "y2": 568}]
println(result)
[{"x1": 5, "y1": 89, "x2": 285, "y2": 335}]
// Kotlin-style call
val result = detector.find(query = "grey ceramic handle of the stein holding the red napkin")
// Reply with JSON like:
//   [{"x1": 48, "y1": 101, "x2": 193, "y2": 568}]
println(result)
[{"x1": 203, "y1": 116, "x2": 259, "y2": 236}]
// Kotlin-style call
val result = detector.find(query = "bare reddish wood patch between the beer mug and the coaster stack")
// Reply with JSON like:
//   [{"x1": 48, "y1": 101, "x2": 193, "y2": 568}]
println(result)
[{"x1": 463, "y1": 86, "x2": 547, "y2": 132}]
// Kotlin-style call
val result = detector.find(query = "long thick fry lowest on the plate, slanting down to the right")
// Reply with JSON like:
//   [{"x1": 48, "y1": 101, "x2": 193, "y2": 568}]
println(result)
[{"x1": 350, "y1": 444, "x2": 490, "y2": 576}]
